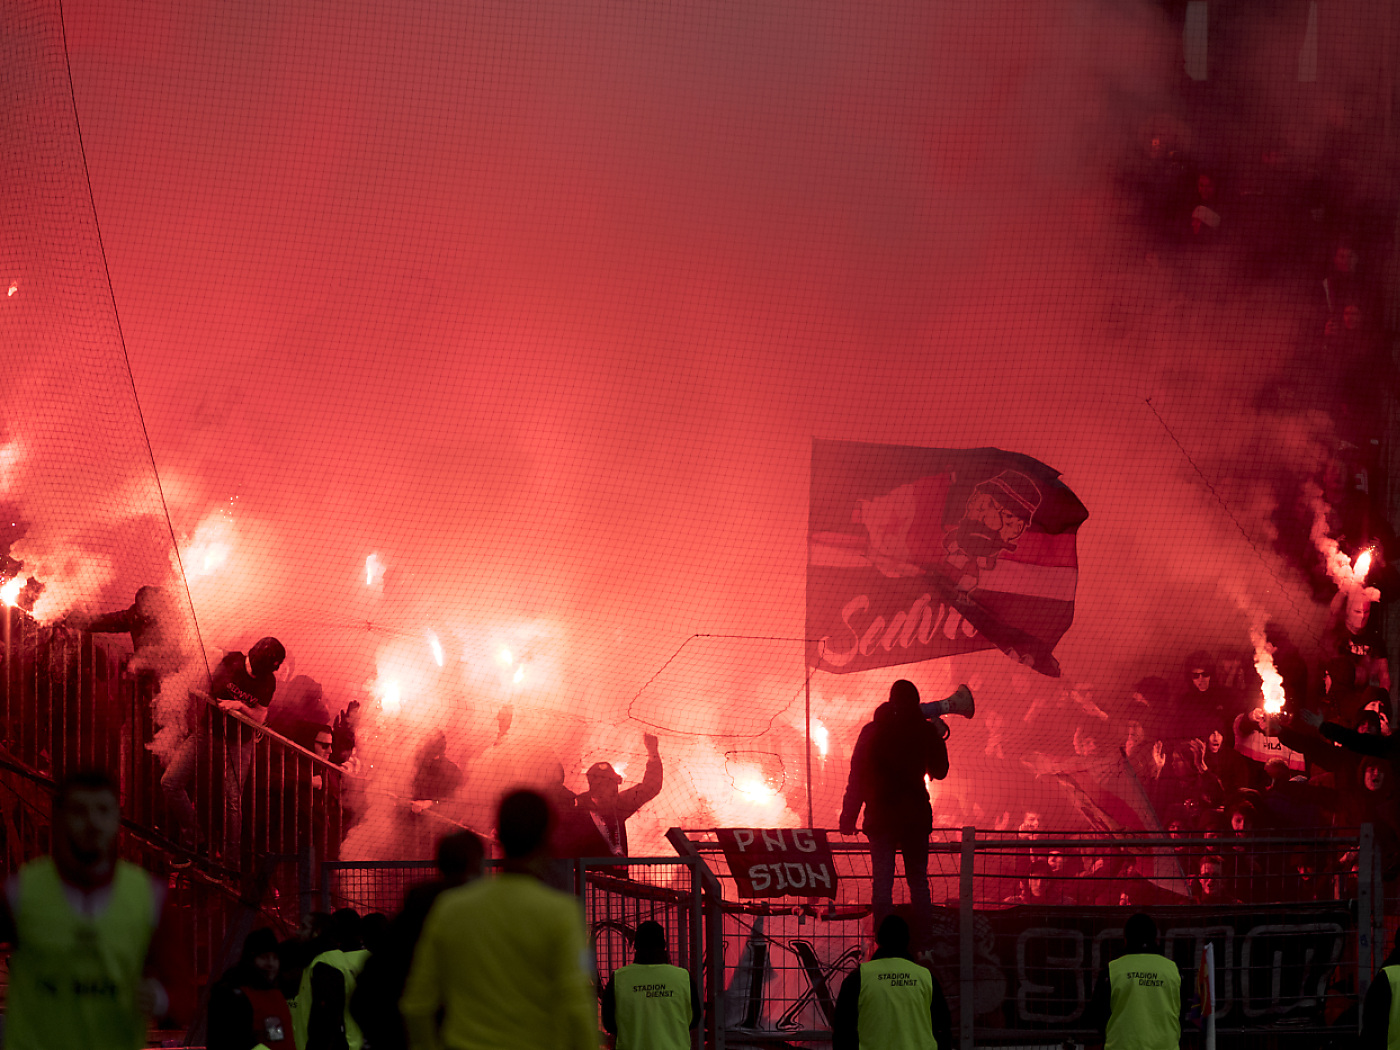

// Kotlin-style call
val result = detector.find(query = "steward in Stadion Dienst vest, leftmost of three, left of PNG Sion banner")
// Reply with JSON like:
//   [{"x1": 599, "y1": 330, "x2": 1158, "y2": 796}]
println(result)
[{"x1": 602, "y1": 921, "x2": 700, "y2": 1050}]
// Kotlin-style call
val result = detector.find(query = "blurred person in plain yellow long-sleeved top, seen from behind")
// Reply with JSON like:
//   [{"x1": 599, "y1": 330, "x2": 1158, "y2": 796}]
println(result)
[{"x1": 399, "y1": 791, "x2": 598, "y2": 1050}]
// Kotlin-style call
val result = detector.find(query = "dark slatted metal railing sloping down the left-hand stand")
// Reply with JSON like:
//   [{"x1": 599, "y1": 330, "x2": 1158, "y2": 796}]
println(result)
[{"x1": 0, "y1": 606, "x2": 357, "y2": 893}]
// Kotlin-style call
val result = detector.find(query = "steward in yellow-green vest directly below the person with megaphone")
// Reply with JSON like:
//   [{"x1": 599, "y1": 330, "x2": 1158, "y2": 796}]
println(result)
[{"x1": 832, "y1": 916, "x2": 952, "y2": 1050}]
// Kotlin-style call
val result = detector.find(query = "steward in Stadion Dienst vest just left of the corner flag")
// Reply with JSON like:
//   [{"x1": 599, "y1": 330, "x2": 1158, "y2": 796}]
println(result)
[{"x1": 1086, "y1": 911, "x2": 1182, "y2": 1050}]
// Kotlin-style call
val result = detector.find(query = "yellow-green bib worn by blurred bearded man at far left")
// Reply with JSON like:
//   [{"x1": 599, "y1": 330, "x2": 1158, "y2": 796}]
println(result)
[{"x1": 4, "y1": 857, "x2": 157, "y2": 1050}]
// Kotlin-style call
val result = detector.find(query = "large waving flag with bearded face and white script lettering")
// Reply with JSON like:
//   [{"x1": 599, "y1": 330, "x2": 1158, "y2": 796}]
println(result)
[{"x1": 806, "y1": 441, "x2": 1089, "y2": 676}]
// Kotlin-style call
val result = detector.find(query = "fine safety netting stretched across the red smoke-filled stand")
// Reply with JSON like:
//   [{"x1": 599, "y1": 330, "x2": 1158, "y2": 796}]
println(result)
[{"x1": 0, "y1": 0, "x2": 1400, "y2": 861}]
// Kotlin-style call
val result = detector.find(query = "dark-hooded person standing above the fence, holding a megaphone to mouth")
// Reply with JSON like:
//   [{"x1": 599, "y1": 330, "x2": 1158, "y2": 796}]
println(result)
[{"x1": 840, "y1": 679, "x2": 948, "y2": 928}]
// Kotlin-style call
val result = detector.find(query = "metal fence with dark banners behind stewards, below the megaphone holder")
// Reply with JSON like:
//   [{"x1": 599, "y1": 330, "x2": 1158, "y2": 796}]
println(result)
[{"x1": 672, "y1": 827, "x2": 1385, "y2": 1049}]
